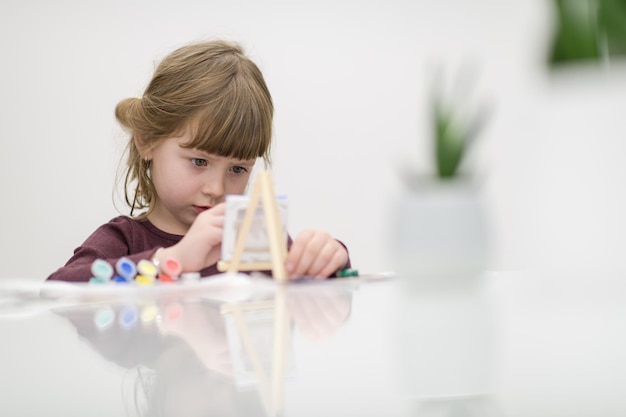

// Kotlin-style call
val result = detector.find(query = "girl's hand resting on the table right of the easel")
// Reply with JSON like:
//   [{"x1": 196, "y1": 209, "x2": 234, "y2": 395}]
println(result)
[{"x1": 285, "y1": 229, "x2": 348, "y2": 278}]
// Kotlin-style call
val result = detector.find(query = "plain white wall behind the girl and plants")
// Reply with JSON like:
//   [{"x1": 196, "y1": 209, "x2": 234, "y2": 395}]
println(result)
[{"x1": 0, "y1": 0, "x2": 626, "y2": 278}]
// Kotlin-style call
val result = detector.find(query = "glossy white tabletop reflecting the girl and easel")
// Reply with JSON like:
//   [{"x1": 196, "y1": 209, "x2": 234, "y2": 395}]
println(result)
[{"x1": 0, "y1": 273, "x2": 626, "y2": 417}]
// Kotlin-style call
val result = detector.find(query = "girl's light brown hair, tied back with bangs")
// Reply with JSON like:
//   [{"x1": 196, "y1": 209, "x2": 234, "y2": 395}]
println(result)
[{"x1": 115, "y1": 41, "x2": 274, "y2": 216}]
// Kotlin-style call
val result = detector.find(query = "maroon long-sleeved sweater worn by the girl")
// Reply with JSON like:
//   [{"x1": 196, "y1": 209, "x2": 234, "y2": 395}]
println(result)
[{"x1": 47, "y1": 216, "x2": 350, "y2": 282}]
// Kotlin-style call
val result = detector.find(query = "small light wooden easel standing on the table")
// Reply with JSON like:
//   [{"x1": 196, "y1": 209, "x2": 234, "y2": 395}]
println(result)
[{"x1": 217, "y1": 171, "x2": 287, "y2": 283}]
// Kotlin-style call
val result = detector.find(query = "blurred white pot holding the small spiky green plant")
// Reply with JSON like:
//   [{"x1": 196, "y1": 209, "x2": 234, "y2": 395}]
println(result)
[{"x1": 389, "y1": 179, "x2": 487, "y2": 286}]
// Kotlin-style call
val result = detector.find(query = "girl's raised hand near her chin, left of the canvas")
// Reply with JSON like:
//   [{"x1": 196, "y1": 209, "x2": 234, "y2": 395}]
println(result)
[{"x1": 159, "y1": 203, "x2": 226, "y2": 272}]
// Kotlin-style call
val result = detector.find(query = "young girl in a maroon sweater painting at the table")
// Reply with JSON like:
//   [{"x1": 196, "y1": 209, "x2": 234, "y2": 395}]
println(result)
[{"x1": 48, "y1": 41, "x2": 349, "y2": 281}]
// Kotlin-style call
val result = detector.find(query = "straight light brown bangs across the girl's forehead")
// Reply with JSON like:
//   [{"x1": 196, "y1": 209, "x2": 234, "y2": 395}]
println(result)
[{"x1": 179, "y1": 81, "x2": 272, "y2": 162}]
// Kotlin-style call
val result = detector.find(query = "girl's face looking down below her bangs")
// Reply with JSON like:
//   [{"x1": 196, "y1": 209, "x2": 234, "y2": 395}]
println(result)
[{"x1": 143, "y1": 134, "x2": 255, "y2": 235}]
